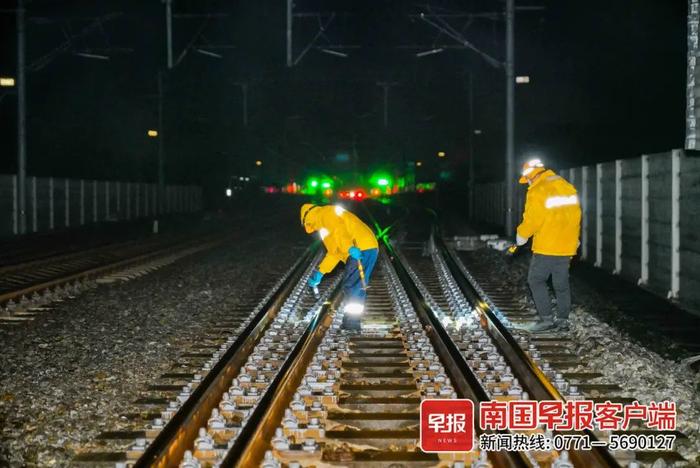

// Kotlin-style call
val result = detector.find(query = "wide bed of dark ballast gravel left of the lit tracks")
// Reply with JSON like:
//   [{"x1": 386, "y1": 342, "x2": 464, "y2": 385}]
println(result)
[{"x1": 0, "y1": 226, "x2": 308, "y2": 467}]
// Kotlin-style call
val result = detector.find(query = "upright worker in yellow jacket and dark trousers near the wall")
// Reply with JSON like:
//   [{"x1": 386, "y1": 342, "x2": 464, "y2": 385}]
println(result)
[{"x1": 516, "y1": 159, "x2": 581, "y2": 332}]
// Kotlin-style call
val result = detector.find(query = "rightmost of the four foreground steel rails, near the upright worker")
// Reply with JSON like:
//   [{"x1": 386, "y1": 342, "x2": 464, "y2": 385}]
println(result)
[{"x1": 433, "y1": 229, "x2": 620, "y2": 468}]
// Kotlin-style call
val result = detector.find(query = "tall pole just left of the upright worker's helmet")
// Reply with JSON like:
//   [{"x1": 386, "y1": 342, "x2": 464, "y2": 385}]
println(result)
[{"x1": 505, "y1": 0, "x2": 515, "y2": 237}]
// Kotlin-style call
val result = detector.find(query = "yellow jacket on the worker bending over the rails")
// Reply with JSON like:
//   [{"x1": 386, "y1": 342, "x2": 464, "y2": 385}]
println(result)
[{"x1": 301, "y1": 204, "x2": 379, "y2": 274}]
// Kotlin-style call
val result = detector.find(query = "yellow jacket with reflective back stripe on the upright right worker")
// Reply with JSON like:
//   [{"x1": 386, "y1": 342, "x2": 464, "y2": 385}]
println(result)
[{"x1": 518, "y1": 170, "x2": 581, "y2": 256}]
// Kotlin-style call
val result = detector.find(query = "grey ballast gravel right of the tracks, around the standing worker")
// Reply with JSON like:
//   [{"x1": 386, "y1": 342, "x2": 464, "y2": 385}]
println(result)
[{"x1": 465, "y1": 248, "x2": 700, "y2": 466}]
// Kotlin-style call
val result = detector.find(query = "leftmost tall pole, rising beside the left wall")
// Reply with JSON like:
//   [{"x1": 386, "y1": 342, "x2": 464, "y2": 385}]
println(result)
[{"x1": 17, "y1": 0, "x2": 27, "y2": 234}]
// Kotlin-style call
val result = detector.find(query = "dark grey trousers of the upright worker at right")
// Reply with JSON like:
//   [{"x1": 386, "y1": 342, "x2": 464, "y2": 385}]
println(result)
[{"x1": 527, "y1": 254, "x2": 571, "y2": 320}]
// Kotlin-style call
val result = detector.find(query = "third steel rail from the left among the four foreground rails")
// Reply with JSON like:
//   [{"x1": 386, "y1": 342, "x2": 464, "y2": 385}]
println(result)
[{"x1": 385, "y1": 241, "x2": 531, "y2": 467}]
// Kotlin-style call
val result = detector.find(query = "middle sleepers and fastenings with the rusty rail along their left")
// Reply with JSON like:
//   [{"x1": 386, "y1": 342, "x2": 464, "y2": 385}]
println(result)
[{"x1": 226, "y1": 258, "x2": 519, "y2": 468}]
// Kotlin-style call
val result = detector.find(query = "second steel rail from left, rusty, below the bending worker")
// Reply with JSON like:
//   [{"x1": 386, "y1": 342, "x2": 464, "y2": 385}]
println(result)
[{"x1": 219, "y1": 283, "x2": 342, "y2": 468}]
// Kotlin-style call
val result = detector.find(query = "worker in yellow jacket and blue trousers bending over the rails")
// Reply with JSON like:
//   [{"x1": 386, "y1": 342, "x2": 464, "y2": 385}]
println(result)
[{"x1": 301, "y1": 203, "x2": 379, "y2": 329}]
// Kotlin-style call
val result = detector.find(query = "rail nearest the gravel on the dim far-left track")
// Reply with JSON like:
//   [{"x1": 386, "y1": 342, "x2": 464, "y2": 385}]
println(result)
[{"x1": 0, "y1": 234, "x2": 223, "y2": 305}]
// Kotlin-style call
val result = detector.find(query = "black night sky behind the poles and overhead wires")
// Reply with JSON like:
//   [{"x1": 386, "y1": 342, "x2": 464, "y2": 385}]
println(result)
[{"x1": 0, "y1": 0, "x2": 687, "y2": 192}]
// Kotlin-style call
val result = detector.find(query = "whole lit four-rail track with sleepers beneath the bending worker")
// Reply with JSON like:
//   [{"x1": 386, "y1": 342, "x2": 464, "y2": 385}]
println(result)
[{"x1": 75, "y1": 220, "x2": 688, "y2": 468}]
